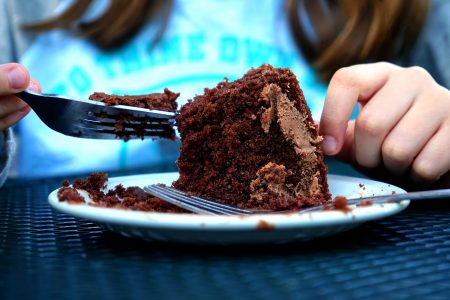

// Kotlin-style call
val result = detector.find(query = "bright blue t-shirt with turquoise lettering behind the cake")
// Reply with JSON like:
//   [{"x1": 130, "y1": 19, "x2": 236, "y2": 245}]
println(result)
[{"x1": 16, "y1": 0, "x2": 326, "y2": 177}]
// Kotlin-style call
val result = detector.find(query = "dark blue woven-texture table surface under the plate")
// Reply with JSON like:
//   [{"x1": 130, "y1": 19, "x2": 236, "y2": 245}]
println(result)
[{"x1": 0, "y1": 166, "x2": 450, "y2": 299}]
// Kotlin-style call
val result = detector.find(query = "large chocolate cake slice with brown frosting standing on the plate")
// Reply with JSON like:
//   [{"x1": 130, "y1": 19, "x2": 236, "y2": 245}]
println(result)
[{"x1": 173, "y1": 65, "x2": 331, "y2": 210}]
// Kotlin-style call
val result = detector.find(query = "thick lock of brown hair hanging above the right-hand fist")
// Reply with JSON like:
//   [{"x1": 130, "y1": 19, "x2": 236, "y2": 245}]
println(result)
[{"x1": 286, "y1": 0, "x2": 428, "y2": 79}]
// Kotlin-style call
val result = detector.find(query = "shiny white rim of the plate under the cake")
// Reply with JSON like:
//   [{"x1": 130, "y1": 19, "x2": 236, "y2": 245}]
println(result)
[{"x1": 48, "y1": 172, "x2": 410, "y2": 231}]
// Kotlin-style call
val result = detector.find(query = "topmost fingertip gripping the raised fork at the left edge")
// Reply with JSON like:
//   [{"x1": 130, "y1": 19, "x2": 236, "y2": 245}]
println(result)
[{"x1": 0, "y1": 63, "x2": 30, "y2": 96}]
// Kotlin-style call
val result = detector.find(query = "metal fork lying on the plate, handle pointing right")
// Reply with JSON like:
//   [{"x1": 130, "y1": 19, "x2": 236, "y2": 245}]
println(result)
[{"x1": 144, "y1": 184, "x2": 450, "y2": 215}]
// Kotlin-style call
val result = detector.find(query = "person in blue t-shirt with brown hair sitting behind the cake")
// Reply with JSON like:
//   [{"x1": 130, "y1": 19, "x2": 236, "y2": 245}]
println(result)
[{"x1": 0, "y1": 0, "x2": 450, "y2": 190}]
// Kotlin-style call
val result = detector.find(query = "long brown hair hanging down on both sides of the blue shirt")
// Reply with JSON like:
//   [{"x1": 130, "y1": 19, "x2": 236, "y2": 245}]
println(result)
[{"x1": 26, "y1": 0, "x2": 428, "y2": 80}]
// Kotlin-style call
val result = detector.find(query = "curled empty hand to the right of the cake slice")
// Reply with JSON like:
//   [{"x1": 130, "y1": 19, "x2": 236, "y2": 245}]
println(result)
[{"x1": 319, "y1": 63, "x2": 450, "y2": 188}]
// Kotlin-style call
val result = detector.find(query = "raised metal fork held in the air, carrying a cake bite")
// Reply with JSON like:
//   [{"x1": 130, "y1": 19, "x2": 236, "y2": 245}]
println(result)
[{"x1": 16, "y1": 90, "x2": 176, "y2": 139}]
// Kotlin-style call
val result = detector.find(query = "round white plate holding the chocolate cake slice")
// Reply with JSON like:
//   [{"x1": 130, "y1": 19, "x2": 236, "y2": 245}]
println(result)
[{"x1": 48, "y1": 173, "x2": 409, "y2": 244}]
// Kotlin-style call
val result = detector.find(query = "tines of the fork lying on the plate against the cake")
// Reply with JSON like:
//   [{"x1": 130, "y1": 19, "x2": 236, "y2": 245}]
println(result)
[{"x1": 144, "y1": 184, "x2": 254, "y2": 215}]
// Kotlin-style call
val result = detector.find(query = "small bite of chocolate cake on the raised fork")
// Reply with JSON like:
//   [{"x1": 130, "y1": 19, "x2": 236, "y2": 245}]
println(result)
[{"x1": 89, "y1": 88, "x2": 180, "y2": 141}]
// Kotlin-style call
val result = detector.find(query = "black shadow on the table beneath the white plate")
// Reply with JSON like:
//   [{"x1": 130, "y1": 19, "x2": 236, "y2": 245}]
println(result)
[{"x1": 96, "y1": 223, "x2": 405, "y2": 256}]
